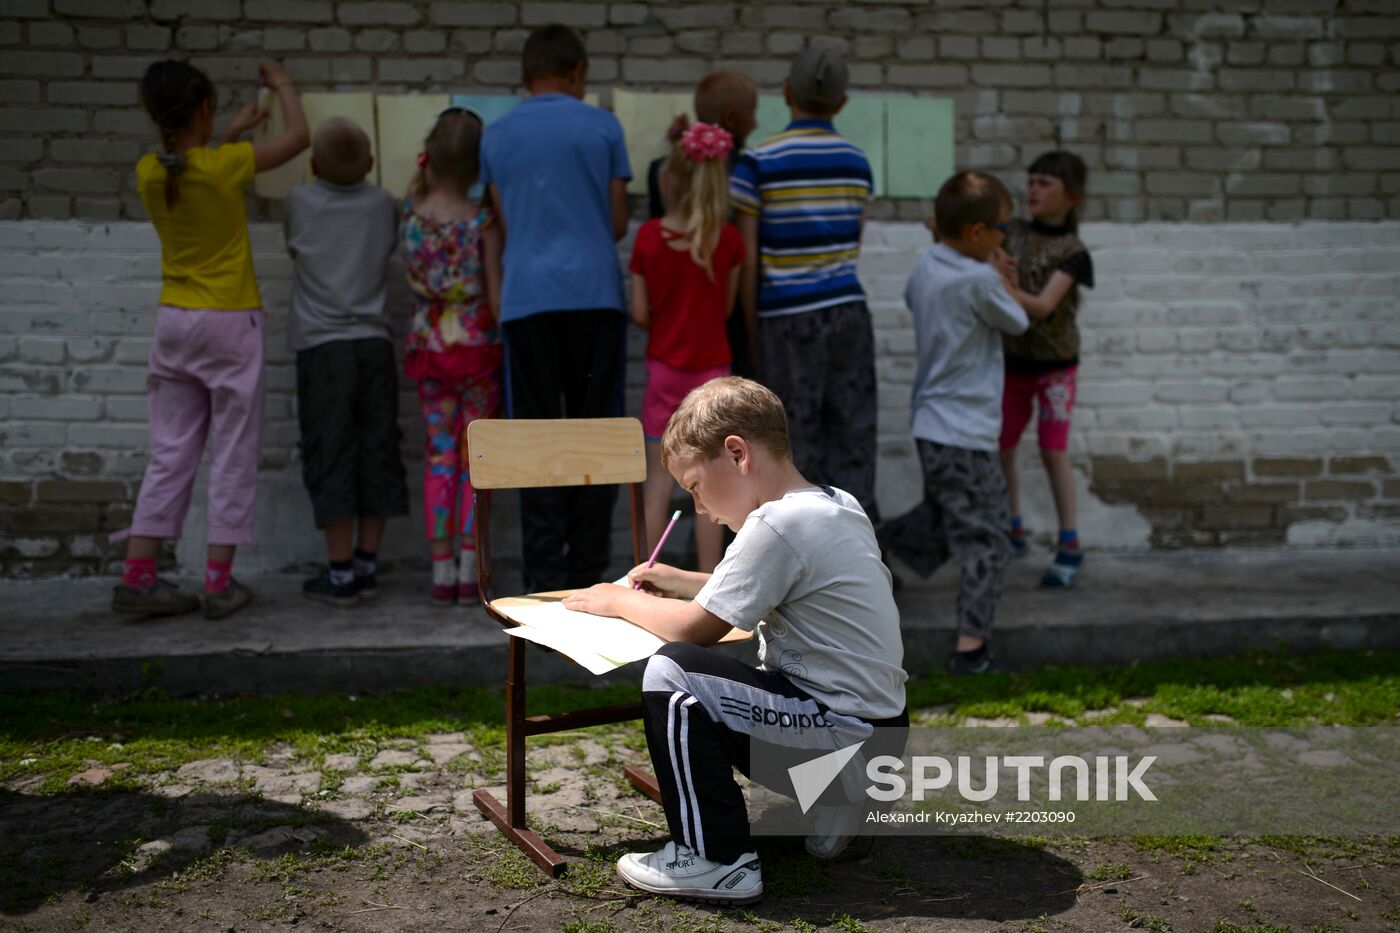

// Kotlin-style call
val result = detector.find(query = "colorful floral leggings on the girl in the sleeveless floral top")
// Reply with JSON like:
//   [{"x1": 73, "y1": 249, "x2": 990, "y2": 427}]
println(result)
[{"x1": 419, "y1": 378, "x2": 501, "y2": 540}]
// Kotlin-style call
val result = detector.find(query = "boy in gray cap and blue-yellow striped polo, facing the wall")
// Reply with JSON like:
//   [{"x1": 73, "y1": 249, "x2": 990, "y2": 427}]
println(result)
[{"x1": 729, "y1": 49, "x2": 879, "y2": 521}]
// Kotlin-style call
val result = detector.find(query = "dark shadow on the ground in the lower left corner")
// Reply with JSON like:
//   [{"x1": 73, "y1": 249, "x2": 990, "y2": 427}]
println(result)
[{"x1": 0, "y1": 789, "x2": 368, "y2": 915}]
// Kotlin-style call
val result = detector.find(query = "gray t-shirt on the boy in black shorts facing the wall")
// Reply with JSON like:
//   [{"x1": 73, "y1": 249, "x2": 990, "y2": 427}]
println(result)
[{"x1": 286, "y1": 178, "x2": 399, "y2": 352}]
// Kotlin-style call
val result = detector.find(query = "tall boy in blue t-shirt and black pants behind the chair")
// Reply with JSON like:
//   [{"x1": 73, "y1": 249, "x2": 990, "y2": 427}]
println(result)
[{"x1": 482, "y1": 25, "x2": 631, "y2": 591}]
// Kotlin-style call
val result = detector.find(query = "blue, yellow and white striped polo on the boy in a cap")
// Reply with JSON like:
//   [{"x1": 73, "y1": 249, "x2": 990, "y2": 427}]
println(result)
[{"x1": 729, "y1": 119, "x2": 872, "y2": 318}]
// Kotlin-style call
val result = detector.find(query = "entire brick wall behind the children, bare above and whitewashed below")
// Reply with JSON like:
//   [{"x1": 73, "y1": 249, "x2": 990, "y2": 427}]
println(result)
[{"x1": 0, "y1": 0, "x2": 1400, "y2": 576}]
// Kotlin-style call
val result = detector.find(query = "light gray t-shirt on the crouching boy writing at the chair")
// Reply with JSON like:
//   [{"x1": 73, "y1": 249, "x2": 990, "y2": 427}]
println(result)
[{"x1": 696, "y1": 486, "x2": 909, "y2": 719}]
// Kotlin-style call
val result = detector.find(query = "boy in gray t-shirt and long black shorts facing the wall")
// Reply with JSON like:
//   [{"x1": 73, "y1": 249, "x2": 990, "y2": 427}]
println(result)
[{"x1": 286, "y1": 118, "x2": 409, "y2": 607}]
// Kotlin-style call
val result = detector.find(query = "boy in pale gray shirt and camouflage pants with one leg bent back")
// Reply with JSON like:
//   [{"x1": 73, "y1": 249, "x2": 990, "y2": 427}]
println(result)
[{"x1": 879, "y1": 172, "x2": 1047, "y2": 674}]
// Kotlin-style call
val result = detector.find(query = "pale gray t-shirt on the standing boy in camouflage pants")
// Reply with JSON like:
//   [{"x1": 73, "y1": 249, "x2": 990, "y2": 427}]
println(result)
[{"x1": 904, "y1": 244, "x2": 1030, "y2": 451}]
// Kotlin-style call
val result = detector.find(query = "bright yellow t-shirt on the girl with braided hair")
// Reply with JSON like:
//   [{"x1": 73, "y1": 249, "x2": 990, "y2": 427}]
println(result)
[{"x1": 136, "y1": 143, "x2": 262, "y2": 311}]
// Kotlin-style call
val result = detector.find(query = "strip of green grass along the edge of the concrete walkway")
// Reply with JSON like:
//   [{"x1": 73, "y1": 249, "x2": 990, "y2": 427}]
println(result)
[{"x1": 0, "y1": 651, "x2": 1400, "y2": 793}]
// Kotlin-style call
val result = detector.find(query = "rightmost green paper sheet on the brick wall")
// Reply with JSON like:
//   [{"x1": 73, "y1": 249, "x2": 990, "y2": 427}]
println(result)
[{"x1": 885, "y1": 97, "x2": 955, "y2": 199}]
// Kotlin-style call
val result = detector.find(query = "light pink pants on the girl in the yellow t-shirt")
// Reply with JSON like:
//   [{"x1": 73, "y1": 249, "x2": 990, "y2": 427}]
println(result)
[{"x1": 113, "y1": 305, "x2": 265, "y2": 545}]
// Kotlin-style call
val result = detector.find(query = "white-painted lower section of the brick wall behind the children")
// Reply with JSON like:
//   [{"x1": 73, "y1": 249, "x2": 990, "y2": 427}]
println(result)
[{"x1": 0, "y1": 221, "x2": 1400, "y2": 576}]
